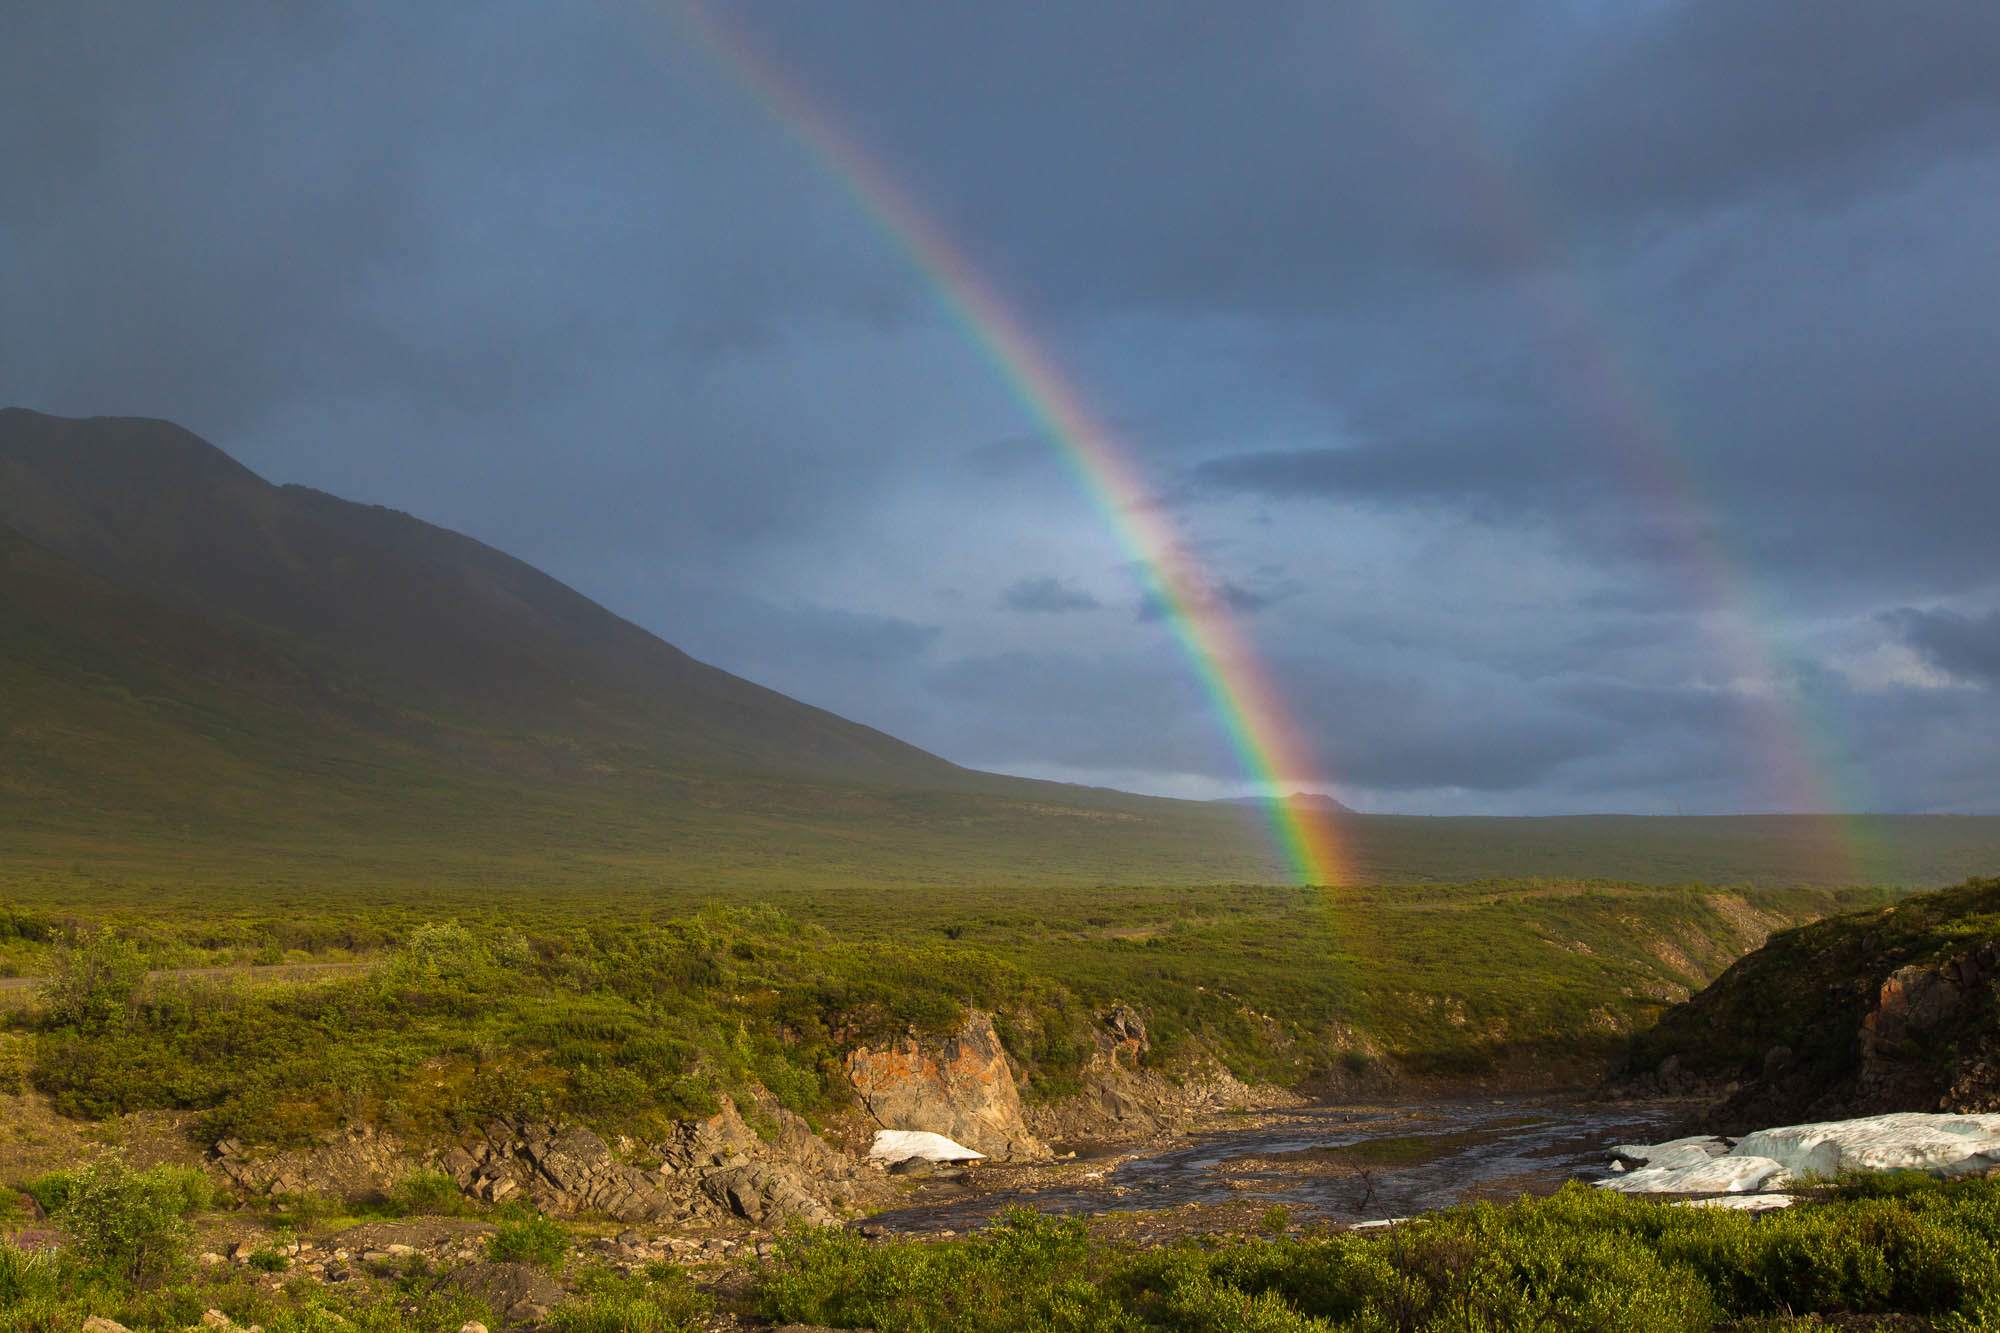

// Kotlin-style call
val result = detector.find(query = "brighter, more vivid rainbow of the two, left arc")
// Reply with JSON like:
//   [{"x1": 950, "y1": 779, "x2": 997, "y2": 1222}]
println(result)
[{"x1": 674, "y1": 0, "x2": 1352, "y2": 885}]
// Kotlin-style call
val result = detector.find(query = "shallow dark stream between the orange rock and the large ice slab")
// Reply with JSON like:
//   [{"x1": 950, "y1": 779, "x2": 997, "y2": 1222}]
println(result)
[{"x1": 870, "y1": 1097, "x2": 1678, "y2": 1233}]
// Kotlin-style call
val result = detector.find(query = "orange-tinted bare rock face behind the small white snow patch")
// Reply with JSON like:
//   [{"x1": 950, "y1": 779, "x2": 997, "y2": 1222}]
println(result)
[{"x1": 846, "y1": 1011, "x2": 1050, "y2": 1161}]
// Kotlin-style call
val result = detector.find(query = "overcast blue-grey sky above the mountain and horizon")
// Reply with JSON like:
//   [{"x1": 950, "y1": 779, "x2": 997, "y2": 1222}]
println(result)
[{"x1": 0, "y1": 0, "x2": 2000, "y2": 813}]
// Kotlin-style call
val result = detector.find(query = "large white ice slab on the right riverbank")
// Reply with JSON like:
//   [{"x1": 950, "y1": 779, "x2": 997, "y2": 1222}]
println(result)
[{"x1": 1598, "y1": 1111, "x2": 2000, "y2": 1195}]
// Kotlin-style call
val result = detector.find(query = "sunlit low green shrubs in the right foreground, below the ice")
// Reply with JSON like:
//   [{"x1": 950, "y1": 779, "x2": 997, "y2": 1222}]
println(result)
[{"x1": 758, "y1": 1177, "x2": 2000, "y2": 1333}]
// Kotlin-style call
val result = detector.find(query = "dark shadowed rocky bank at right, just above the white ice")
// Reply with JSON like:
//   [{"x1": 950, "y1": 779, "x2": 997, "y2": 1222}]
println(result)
[{"x1": 1628, "y1": 879, "x2": 2000, "y2": 1123}]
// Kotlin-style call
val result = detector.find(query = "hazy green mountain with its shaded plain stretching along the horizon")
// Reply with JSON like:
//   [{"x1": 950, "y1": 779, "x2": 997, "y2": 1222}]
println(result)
[{"x1": 0, "y1": 410, "x2": 2000, "y2": 888}]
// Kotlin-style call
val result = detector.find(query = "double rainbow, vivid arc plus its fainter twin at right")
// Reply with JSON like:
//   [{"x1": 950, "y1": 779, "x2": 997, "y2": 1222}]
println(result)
[{"x1": 672, "y1": 0, "x2": 1862, "y2": 885}]
